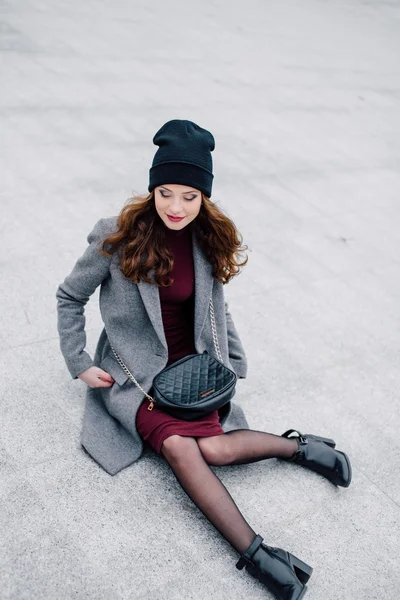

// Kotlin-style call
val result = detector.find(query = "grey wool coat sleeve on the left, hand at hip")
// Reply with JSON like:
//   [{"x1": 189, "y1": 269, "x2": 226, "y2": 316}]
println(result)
[{"x1": 56, "y1": 219, "x2": 111, "y2": 378}]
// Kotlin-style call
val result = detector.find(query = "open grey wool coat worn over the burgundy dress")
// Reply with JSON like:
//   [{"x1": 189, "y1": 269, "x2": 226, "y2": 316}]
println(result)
[{"x1": 56, "y1": 217, "x2": 248, "y2": 475}]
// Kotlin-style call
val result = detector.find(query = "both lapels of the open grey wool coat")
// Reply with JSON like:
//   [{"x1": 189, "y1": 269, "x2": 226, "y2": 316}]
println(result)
[{"x1": 138, "y1": 234, "x2": 214, "y2": 348}]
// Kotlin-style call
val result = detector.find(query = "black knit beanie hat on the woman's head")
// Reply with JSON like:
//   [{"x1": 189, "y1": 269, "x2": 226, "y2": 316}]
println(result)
[{"x1": 149, "y1": 119, "x2": 215, "y2": 197}]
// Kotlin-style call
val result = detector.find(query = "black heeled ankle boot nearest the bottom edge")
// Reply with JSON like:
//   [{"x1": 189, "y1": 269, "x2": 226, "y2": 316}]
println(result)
[{"x1": 236, "y1": 535, "x2": 312, "y2": 600}]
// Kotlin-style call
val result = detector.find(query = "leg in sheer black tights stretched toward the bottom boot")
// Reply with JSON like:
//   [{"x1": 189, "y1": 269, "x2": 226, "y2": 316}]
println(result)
[{"x1": 161, "y1": 435, "x2": 256, "y2": 554}]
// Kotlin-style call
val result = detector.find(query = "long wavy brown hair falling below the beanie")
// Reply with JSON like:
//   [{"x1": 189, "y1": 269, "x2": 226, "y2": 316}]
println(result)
[{"x1": 102, "y1": 192, "x2": 248, "y2": 287}]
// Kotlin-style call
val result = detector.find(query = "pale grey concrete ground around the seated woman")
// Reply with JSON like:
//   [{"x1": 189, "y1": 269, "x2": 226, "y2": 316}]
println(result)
[{"x1": 0, "y1": 0, "x2": 400, "y2": 600}]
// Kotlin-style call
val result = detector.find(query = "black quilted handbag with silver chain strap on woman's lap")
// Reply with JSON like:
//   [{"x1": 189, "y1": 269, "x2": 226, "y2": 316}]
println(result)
[{"x1": 111, "y1": 299, "x2": 237, "y2": 421}]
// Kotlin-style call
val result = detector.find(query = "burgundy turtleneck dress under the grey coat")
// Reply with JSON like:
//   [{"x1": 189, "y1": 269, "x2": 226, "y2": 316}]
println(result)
[{"x1": 136, "y1": 226, "x2": 224, "y2": 453}]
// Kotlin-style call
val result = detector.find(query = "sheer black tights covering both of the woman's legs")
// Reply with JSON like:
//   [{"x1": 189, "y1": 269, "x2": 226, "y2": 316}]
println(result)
[{"x1": 161, "y1": 429, "x2": 298, "y2": 554}]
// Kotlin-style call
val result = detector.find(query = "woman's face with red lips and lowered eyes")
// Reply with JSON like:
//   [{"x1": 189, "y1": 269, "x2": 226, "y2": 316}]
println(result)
[{"x1": 154, "y1": 183, "x2": 202, "y2": 231}]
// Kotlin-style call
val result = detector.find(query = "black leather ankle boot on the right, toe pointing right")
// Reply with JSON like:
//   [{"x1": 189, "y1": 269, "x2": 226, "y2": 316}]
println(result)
[{"x1": 282, "y1": 429, "x2": 351, "y2": 487}]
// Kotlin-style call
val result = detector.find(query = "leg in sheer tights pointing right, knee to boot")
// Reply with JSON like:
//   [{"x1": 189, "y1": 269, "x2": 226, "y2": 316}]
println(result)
[{"x1": 197, "y1": 429, "x2": 299, "y2": 466}]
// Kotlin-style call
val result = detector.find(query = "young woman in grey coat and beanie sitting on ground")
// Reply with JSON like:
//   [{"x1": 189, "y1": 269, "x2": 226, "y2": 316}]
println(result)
[{"x1": 57, "y1": 120, "x2": 351, "y2": 600}]
